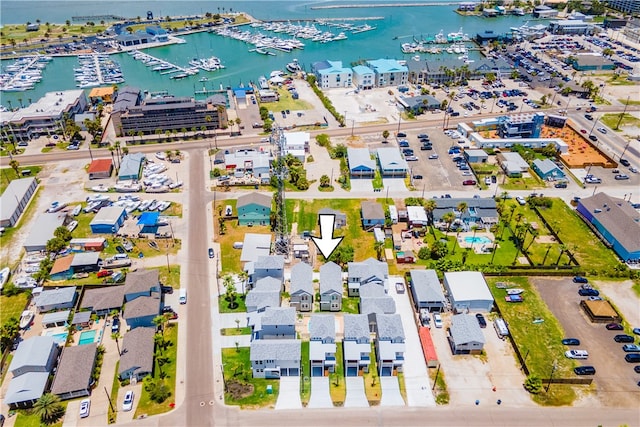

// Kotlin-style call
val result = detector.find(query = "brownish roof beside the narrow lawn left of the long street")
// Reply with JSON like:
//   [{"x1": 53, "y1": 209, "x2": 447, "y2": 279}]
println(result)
[{"x1": 118, "y1": 328, "x2": 156, "y2": 375}]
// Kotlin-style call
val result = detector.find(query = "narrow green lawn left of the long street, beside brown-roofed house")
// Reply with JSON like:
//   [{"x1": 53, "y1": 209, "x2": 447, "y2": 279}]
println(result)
[{"x1": 134, "y1": 323, "x2": 178, "y2": 418}]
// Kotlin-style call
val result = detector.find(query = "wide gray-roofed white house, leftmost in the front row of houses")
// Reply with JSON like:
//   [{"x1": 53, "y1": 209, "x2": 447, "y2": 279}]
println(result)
[{"x1": 249, "y1": 339, "x2": 302, "y2": 379}]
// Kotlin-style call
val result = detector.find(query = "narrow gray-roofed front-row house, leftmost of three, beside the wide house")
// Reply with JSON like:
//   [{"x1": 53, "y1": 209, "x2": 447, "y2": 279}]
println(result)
[{"x1": 309, "y1": 314, "x2": 336, "y2": 377}]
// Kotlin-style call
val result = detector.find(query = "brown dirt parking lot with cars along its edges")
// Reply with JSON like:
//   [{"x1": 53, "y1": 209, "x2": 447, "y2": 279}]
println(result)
[{"x1": 531, "y1": 277, "x2": 640, "y2": 407}]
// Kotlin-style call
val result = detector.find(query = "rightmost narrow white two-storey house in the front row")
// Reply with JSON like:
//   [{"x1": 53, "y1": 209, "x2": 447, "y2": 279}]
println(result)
[{"x1": 375, "y1": 314, "x2": 405, "y2": 377}]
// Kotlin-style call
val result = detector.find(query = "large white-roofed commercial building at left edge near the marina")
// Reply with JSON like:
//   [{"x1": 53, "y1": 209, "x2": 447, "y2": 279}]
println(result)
[{"x1": 0, "y1": 89, "x2": 88, "y2": 141}]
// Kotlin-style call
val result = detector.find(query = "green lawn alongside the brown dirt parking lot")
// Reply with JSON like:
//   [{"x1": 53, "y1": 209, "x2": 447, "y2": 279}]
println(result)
[{"x1": 487, "y1": 277, "x2": 577, "y2": 405}]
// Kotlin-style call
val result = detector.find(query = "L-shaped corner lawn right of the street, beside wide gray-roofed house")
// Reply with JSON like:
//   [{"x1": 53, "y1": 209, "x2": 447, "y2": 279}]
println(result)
[{"x1": 222, "y1": 347, "x2": 280, "y2": 409}]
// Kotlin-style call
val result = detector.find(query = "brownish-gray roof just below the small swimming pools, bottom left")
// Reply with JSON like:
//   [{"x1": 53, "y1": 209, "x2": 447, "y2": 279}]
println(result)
[{"x1": 51, "y1": 343, "x2": 98, "y2": 394}]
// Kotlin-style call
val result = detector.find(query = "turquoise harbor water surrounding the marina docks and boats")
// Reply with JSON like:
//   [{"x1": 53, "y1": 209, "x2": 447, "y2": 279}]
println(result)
[{"x1": 0, "y1": 0, "x2": 530, "y2": 108}]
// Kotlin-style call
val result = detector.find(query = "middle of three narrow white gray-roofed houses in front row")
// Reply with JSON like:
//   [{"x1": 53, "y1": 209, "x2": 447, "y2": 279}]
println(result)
[{"x1": 342, "y1": 314, "x2": 371, "y2": 377}]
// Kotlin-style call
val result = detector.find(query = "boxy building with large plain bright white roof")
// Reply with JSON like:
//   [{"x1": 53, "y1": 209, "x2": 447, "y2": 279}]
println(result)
[{"x1": 444, "y1": 271, "x2": 493, "y2": 313}]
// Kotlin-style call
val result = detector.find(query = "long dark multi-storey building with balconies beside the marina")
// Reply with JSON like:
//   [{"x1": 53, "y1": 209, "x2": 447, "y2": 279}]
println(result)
[{"x1": 111, "y1": 88, "x2": 228, "y2": 136}]
